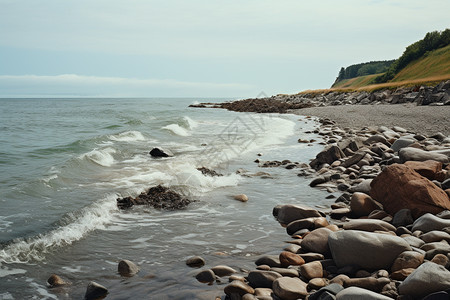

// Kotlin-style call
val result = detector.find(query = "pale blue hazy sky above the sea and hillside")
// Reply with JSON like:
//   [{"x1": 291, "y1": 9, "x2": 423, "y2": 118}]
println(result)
[{"x1": 0, "y1": 0, "x2": 450, "y2": 98}]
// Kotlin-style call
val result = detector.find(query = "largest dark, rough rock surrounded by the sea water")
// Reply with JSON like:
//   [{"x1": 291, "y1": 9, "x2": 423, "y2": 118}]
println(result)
[{"x1": 117, "y1": 185, "x2": 192, "y2": 210}]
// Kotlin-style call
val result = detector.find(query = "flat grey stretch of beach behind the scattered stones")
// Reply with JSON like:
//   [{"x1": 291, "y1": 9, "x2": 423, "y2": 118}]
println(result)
[{"x1": 293, "y1": 104, "x2": 450, "y2": 136}]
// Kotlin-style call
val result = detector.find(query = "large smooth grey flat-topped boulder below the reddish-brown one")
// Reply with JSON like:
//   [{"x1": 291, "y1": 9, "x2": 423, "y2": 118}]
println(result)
[{"x1": 328, "y1": 230, "x2": 411, "y2": 270}]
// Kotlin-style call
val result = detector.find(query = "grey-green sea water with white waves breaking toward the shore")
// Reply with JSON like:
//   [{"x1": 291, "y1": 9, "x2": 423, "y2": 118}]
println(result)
[{"x1": 0, "y1": 98, "x2": 327, "y2": 299}]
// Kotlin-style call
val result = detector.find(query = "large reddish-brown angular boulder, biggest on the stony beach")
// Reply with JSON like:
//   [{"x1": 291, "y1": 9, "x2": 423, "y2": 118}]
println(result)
[{"x1": 370, "y1": 164, "x2": 450, "y2": 218}]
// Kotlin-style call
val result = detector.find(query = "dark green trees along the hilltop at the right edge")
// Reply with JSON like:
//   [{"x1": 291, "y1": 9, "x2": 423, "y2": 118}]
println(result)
[{"x1": 374, "y1": 28, "x2": 450, "y2": 83}]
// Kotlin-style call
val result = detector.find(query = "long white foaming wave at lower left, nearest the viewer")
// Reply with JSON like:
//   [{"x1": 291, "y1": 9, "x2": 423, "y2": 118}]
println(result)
[{"x1": 0, "y1": 195, "x2": 118, "y2": 263}]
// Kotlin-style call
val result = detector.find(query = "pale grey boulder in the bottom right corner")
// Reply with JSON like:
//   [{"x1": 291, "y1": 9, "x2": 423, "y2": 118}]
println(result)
[{"x1": 398, "y1": 262, "x2": 450, "y2": 298}]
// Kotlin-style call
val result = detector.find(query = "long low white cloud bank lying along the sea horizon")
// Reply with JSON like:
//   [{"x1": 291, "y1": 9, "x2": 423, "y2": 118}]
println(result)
[{"x1": 0, "y1": 74, "x2": 255, "y2": 97}]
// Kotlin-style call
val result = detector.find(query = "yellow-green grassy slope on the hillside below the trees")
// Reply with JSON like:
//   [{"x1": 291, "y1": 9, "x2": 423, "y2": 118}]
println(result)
[{"x1": 331, "y1": 45, "x2": 450, "y2": 91}]
